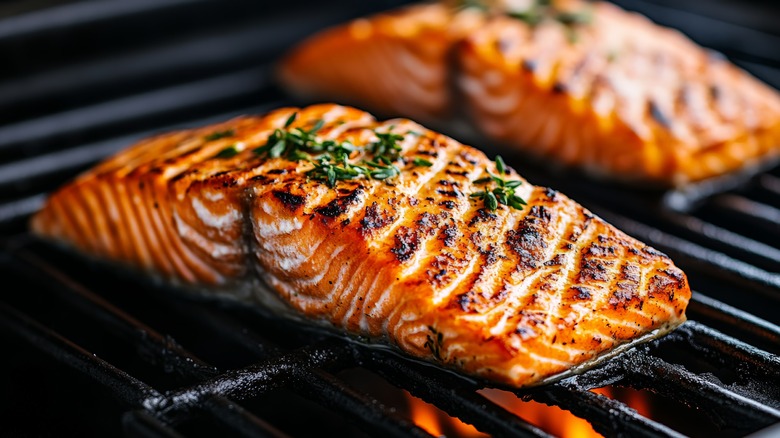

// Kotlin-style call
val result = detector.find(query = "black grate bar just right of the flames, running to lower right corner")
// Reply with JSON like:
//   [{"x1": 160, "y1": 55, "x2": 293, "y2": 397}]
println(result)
[{"x1": 626, "y1": 354, "x2": 780, "y2": 430}]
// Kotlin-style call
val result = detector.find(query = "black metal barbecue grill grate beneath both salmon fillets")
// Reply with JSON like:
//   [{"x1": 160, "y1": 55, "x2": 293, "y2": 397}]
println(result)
[{"x1": 0, "y1": 0, "x2": 780, "y2": 437}]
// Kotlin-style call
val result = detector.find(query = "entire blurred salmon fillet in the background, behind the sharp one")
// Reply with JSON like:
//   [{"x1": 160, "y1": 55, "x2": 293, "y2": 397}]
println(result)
[{"x1": 279, "y1": 0, "x2": 780, "y2": 186}]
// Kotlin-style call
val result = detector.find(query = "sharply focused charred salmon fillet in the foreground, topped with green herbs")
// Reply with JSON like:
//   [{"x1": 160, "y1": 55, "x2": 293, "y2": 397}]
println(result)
[{"x1": 31, "y1": 104, "x2": 690, "y2": 387}]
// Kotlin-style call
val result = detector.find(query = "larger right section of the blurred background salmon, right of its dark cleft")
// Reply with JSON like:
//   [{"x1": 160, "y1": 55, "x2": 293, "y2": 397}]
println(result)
[{"x1": 459, "y1": 1, "x2": 780, "y2": 185}]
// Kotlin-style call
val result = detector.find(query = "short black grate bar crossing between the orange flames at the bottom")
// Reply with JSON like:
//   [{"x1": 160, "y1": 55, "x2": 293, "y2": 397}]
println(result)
[{"x1": 531, "y1": 379, "x2": 683, "y2": 438}]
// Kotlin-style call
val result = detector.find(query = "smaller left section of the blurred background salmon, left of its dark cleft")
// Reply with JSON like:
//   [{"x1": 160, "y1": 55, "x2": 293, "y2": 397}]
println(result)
[{"x1": 279, "y1": 3, "x2": 485, "y2": 121}]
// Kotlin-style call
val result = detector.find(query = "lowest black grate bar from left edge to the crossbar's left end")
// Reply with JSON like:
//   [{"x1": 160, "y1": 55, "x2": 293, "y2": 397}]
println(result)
[{"x1": 0, "y1": 303, "x2": 160, "y2": 406}]
